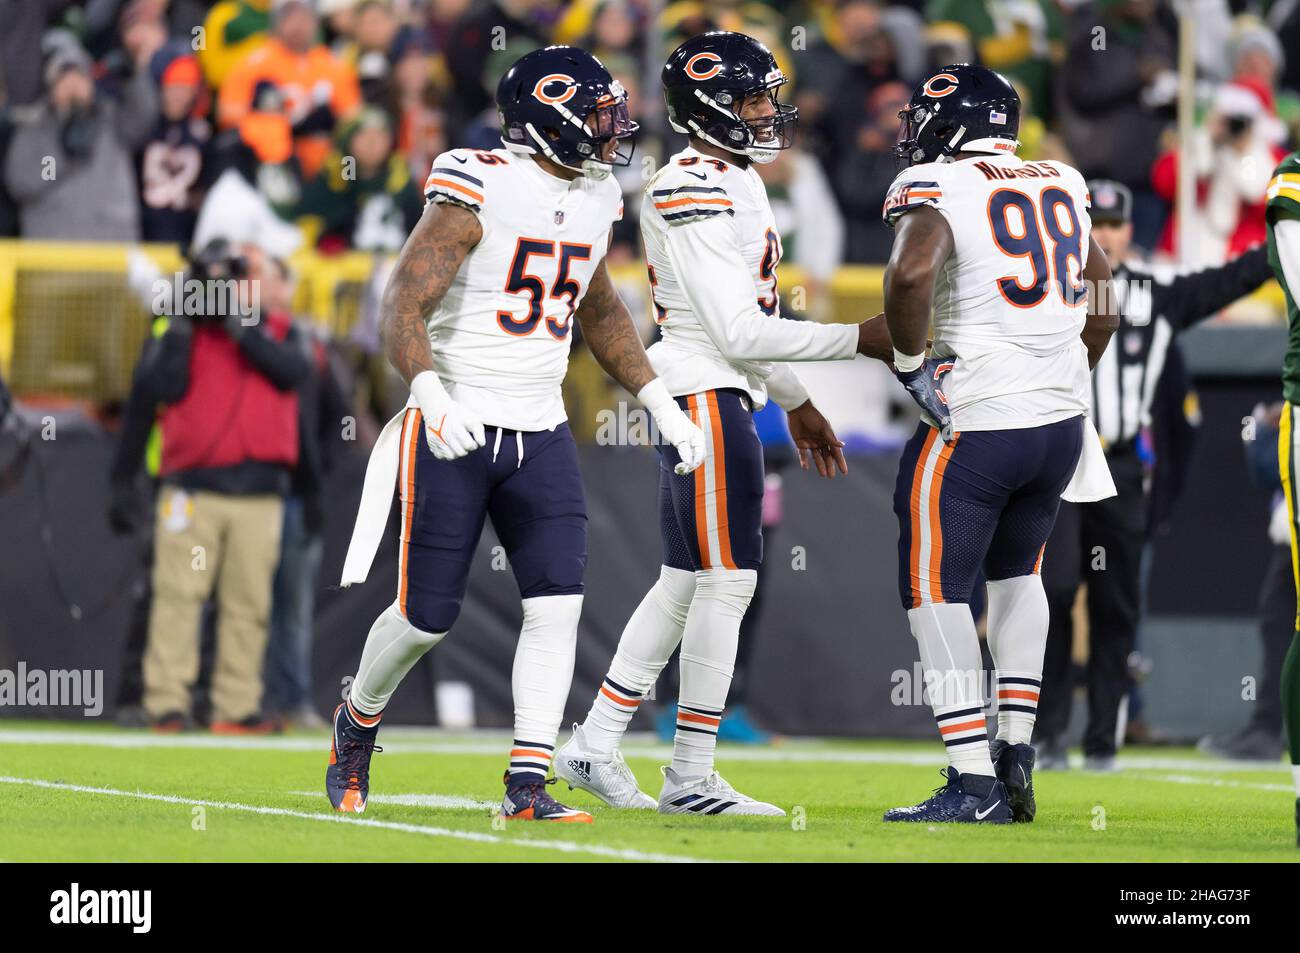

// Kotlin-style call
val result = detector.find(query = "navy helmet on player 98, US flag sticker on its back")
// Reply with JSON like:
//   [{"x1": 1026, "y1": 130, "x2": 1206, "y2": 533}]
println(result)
[{"x1": 894, "y1": 62, "x2": 1021, "y2": 165}]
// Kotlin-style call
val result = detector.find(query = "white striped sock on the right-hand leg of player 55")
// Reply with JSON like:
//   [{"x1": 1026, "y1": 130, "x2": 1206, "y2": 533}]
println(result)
[{"x1": 510, "y1": 594, "x2": 582, "y2": 780}]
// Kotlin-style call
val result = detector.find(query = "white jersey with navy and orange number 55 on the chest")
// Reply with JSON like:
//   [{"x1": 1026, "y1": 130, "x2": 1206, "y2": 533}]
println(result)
[{"x1": 424, "y1": 150, "x2": 623, "y2": 430}]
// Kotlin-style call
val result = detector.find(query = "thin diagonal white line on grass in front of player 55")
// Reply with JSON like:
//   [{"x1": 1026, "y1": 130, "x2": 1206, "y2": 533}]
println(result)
[{"x1": 0, "y1": 775, "x2": 710, "y2": 863}]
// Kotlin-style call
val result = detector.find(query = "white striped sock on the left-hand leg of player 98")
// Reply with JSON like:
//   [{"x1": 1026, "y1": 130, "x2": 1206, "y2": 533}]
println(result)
[{"x1": 907, "y1": 602, "x2": 993, "y2": 775}]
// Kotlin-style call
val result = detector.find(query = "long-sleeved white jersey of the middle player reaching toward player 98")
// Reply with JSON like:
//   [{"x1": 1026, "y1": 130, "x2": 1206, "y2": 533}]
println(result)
[{"x1": 641, "y1": 148, "x2": 858, "y2": 410}]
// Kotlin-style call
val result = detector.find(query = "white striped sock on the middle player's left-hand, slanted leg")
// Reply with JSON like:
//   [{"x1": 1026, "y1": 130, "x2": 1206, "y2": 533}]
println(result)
[{"x1": 582, "y1": 566, "x2": 696, "y2": 753}]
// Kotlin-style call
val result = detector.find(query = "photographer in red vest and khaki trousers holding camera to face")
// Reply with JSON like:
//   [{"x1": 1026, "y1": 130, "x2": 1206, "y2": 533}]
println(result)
[{"x1": 137, "y1": 239, "x2": 309, "y2": 733}]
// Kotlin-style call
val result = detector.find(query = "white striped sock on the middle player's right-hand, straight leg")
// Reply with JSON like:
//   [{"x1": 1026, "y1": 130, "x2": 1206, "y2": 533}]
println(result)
[{"x1": 672, "y1": 569, "x2": 758, "y2": 777}]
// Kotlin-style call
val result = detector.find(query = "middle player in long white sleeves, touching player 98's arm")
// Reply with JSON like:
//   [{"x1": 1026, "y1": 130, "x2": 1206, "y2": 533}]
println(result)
[{"x1": 555, "y1": 33, "x2": 892, "y2": 815}]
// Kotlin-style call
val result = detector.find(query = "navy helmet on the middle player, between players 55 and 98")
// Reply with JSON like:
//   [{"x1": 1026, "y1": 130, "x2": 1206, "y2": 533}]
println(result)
[{"x1": 663, "y1": 31, "x2": 800, "y2": 163}]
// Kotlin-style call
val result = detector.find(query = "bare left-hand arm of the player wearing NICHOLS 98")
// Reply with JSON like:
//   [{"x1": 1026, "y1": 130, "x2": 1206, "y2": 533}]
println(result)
[{"x1": 885, "y1": 207, "x2": 953, "y2": 354}]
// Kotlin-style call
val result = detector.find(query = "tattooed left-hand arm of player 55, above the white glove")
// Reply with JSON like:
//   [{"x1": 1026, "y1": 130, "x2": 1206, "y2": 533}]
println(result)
[{"x1": 380, "y1": 202, "x2": 484, "y2": 384}]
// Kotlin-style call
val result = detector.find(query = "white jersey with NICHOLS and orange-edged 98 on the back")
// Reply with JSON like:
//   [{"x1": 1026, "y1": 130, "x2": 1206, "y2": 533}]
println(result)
[{"x1": 884, "y1": 155, "x2": 1092, "y2": 432}]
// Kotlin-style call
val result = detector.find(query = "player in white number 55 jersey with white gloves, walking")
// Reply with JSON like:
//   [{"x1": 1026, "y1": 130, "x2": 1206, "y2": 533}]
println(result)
[{"x1": 325, "y1": 47, "x2": 705, "y2": 822}]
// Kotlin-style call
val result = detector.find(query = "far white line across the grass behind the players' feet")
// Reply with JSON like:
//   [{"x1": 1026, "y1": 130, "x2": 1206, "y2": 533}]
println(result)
[{"x1": 0, "y1": 727, "x2": 1286, "y2": 774}]
